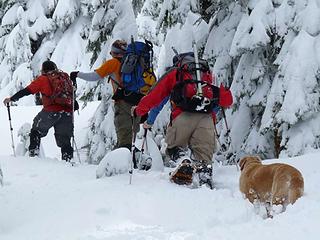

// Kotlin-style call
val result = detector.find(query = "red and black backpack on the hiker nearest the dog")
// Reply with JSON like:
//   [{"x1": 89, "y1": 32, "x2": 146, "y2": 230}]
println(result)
[{"x1": 170, "y1": 52, "x2": 219, "y2": 113}]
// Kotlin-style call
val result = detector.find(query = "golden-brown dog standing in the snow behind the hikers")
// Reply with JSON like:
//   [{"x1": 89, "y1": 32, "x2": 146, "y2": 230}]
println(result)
[{"x1": 239, "y1": 156, "x2": 304, "y2": 217}]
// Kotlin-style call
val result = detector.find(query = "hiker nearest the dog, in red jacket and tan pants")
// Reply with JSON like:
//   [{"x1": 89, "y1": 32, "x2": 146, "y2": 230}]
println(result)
[{"x1": 132, "y1": 53, "x2": 232, "y2": 188}]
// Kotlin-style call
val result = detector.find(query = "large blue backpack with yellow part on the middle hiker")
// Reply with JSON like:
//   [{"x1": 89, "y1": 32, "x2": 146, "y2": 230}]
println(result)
[{"x1": 121, "y1": 39, "x2": 156, "y2": 100}]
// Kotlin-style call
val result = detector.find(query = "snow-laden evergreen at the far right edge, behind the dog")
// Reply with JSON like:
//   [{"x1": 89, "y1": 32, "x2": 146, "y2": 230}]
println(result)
[{"x1": 261, "y1": 1, "x2": 320, "y2": 156}]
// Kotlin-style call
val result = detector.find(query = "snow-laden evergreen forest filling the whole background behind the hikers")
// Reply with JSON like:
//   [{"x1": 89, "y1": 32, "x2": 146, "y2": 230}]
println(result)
[{"x1": 0, "y1": 0, "x2": 320, "y2": 163}]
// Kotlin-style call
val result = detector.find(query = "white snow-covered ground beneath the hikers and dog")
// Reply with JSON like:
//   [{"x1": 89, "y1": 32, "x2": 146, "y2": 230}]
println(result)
[{"x1": 0, "y1": 103, "x2": 320, "y2": 240}]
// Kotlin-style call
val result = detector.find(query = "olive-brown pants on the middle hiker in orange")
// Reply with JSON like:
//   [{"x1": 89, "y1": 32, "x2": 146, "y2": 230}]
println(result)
[{"x1": 114, "y1": 100, "x2": 139, "y2": 149}]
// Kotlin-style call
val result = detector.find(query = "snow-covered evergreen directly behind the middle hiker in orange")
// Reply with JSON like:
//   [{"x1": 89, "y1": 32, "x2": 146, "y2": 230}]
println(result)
[{"x1": 84, "y1": 0, "x2": 137, "y2": 163}]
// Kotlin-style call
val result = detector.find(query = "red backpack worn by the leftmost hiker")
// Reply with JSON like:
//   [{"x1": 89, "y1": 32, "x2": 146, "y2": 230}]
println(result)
[{"x1": 46, "y1": 71, "x2": 73, "y2": 108}]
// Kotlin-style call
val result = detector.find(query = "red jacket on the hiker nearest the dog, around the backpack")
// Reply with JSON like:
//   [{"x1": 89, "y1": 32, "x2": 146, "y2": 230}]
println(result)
[{"x1": 136, "y1": 69, "x2": 233, "y2": 119}]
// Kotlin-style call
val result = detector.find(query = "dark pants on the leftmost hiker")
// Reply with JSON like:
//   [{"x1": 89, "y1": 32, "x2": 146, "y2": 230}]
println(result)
[{"x1": 29, "y1": 110, "x2": 73, "y2": 161}]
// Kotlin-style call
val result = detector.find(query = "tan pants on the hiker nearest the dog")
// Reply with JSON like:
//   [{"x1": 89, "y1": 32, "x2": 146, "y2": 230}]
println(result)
[{"x1": 166, "y1": 112, "x2": 216, "y2": 164}]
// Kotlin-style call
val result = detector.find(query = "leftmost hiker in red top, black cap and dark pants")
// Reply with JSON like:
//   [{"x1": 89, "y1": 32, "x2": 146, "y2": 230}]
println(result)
[{"x1": 3, "y1": 61, "x2": 78, "y2": 161}]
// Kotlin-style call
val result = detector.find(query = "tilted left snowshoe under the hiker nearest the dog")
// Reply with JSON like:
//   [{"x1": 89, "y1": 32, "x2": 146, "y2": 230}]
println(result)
[{"x1": 170, "y1": 159, "x2": 194, "y2": 185}]
